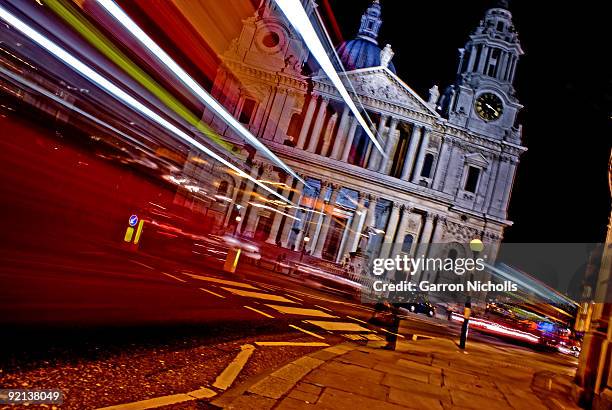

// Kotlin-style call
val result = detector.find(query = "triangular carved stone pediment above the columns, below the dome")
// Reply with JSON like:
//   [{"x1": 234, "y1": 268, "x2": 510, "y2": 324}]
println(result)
[{"x1": 319, "y1": 67, "x2": 438, "y2": 116}]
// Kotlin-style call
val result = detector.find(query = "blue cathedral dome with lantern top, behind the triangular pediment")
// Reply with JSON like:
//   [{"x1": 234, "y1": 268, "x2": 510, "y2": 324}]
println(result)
[{"x1": 337, "y1": 0, "x2": 395, "y2": 73}]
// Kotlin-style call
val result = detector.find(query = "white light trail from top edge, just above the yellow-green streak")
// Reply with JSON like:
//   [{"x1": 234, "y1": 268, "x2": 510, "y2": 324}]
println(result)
[{"x1": 98, "y1": 0, "x2": 308, "y2": 185}]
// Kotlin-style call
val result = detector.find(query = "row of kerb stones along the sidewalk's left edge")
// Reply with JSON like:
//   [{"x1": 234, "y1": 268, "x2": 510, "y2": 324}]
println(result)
[{"x1": 210, "y1": 343, "x2": 359, "y2": 409}]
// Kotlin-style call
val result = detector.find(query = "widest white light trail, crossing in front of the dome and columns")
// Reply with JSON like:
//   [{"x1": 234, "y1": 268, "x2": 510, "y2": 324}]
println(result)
[{"x1": 275, "y1": 0, "x2": 387, "y2": 158}]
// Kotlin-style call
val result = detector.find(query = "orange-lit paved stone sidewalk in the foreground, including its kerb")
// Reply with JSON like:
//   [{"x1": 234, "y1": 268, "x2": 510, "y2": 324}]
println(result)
[{"x1": 212, "y1": 339, "x2": 577, "y2": 410}]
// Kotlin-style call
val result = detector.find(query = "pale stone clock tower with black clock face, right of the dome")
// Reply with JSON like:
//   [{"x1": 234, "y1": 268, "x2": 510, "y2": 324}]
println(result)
[{"x1": 438, "y1": 1, "x2": 523, "y2": 143}]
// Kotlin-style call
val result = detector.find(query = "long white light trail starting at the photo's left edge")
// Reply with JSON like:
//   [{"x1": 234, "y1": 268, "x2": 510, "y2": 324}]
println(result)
[{"x1": 0, "y1": 6, "x2": 292, "y2": 204}]
